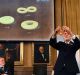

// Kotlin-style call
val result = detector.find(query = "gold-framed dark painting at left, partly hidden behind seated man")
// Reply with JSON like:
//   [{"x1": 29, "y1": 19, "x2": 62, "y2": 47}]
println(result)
[{"x1": 0, "y1": 41, "x2": 23, "y2": 65}]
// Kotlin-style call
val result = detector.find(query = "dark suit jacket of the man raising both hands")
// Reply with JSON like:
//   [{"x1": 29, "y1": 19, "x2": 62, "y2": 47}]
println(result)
[{"x1": 50, "y1": 37, "x2": 80, "y2": 73}]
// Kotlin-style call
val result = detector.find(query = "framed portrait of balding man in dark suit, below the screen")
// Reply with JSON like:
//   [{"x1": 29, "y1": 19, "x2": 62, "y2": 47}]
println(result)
[{"x1": 33, "y1": 41, "x2": 51, "y2": 64}]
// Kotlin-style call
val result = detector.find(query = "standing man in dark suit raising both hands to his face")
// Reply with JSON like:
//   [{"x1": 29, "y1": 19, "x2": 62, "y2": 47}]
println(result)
[{"x1": 50, "y1": 26, "x2": 80, "y2": 75}]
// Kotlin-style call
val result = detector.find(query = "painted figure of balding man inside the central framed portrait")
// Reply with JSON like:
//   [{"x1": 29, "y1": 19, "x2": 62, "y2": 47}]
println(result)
[{"x1": 34, "y1": 46, "x2": 49, "y2": 63}]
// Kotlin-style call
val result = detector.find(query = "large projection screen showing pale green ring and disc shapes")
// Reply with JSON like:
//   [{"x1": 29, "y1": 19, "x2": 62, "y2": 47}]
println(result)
[{"x1": 0, "y1": 0, "x2": 54, "y2": 41}]
